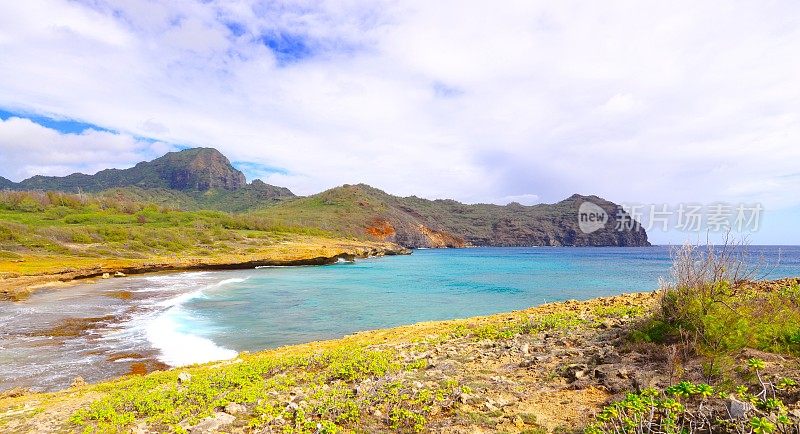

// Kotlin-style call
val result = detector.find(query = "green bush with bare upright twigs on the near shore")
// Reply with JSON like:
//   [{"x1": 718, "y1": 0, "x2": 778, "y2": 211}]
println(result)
[{"x1": 644, "y1": 239, "x2": 800, "y2": 357}]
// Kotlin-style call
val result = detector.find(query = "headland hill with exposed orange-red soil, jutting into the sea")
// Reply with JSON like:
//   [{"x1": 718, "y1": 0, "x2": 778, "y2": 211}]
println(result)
[{"x1": 260, "y1": 184, "x2": 650, "y2": 247}]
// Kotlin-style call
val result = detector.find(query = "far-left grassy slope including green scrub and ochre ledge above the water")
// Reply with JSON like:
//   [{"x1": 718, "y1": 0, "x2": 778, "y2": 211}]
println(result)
[{"x1": 0, "y1": 192, "x2": 406, "y2": 300}]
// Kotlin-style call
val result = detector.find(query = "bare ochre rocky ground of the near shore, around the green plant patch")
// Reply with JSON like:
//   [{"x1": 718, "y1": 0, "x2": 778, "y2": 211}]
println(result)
[{"x1": 0, "y1": 293, "x2": 660, "y2": 433}]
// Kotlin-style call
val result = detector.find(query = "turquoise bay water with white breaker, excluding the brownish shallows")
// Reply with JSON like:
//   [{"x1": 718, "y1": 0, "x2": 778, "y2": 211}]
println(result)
[{"x1": 178, "y1": 247, "x2": 800, "y2": 351}]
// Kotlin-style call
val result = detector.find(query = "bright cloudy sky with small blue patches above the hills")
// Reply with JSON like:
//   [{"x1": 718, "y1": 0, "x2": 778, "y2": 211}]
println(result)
[{"x1": 0, "y1": 0, "x2": 800, "y2": 244}]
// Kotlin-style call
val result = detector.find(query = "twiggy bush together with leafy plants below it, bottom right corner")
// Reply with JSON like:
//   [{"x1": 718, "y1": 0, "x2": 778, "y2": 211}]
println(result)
[{"x1": 586, "y1": 241, "x2": 800, "y2": 434}]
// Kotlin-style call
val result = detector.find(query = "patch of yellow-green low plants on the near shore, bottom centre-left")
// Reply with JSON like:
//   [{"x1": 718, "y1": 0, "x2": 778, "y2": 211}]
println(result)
[{"x1": 71, "y1": 346, "x2": 459, "y2": 432}]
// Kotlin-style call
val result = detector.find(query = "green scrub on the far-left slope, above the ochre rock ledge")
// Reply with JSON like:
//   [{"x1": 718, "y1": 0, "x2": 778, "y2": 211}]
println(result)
[{"x1": 0, "y1": 192, "x2": 330, "y2": 258}]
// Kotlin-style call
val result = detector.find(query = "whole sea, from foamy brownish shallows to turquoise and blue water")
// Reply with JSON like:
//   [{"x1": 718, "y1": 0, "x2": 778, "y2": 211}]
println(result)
[{"x1": 0, "y1": 246, "x2": 800, "y2": 390}]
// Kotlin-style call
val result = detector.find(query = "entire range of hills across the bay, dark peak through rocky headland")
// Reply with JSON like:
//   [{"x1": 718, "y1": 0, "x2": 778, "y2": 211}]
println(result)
[{"x1": 0, "y1": 148, "x2": 649, "y2": 247}]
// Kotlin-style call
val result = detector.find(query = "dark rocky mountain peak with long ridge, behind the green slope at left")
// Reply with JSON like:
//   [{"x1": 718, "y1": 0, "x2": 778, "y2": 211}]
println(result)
[{"x1": 0, "y1": 148, "x2": 295, "y2": 211}]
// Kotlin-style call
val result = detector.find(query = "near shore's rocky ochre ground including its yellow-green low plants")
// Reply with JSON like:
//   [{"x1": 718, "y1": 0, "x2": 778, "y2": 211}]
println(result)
[{"x1": 0, "y1": 286, "x2": 798, "y2": 433}]
